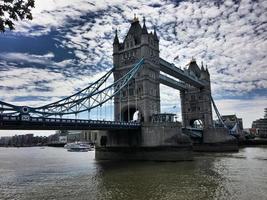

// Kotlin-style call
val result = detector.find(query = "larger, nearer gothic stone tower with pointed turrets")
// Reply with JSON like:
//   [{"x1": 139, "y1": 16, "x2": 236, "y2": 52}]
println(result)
[{"x1": 113, "y1": 17, "x2": 160, "y2": 122}]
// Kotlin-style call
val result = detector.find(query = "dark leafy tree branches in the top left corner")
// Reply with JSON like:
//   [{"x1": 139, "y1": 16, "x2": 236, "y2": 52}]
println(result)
[{"x1": 0, "y1": 0, "x2": 34, "y2": 32}]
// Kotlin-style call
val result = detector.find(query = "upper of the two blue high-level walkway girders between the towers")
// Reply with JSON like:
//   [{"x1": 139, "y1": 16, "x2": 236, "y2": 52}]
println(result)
[{"x1": 159, "y1": 58, "x2": 204, "y2": 88}]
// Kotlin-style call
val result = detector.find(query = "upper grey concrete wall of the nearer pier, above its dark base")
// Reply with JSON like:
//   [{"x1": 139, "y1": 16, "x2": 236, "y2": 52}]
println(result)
[{"x1": 96, "y1": 122, "x2": 191, "y2": 147}]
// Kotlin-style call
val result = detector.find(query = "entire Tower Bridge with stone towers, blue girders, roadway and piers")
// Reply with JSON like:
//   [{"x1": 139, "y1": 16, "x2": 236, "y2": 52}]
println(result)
[{"x1": 0, "y1": 17, "x2": 239, "y2": 160}]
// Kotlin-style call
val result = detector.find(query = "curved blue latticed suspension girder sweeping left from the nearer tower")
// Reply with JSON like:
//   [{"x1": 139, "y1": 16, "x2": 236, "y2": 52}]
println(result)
[{"x1": 0, "y1": 59, "x2": 144, "y2": 117}]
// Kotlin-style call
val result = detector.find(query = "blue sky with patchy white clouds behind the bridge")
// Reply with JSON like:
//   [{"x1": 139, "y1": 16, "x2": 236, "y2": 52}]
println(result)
[{"x1": 0, "y1": 0, "x2": 267, "y2": 136}]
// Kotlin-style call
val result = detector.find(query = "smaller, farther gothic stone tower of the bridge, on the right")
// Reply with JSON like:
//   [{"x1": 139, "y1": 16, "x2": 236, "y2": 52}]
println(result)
[{"x1": 180, "y1": 59, "x2": 213, "y2": 128}]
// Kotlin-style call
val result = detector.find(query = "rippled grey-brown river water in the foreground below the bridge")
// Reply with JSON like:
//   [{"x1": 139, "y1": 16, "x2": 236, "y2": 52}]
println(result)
[{"x1": 0, "y1": 147, "x2": 267, "y2": 200}]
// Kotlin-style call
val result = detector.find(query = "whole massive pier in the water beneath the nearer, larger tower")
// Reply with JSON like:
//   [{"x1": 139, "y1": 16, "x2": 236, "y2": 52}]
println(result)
[{"x1": 95, "y1": 123, "x2": 193, "y2": 161}]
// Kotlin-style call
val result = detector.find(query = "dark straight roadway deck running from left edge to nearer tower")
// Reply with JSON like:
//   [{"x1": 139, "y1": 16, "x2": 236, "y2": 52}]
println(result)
[{"x1": 0, "y1": 116, "x2": 141, "y2": 130}]
